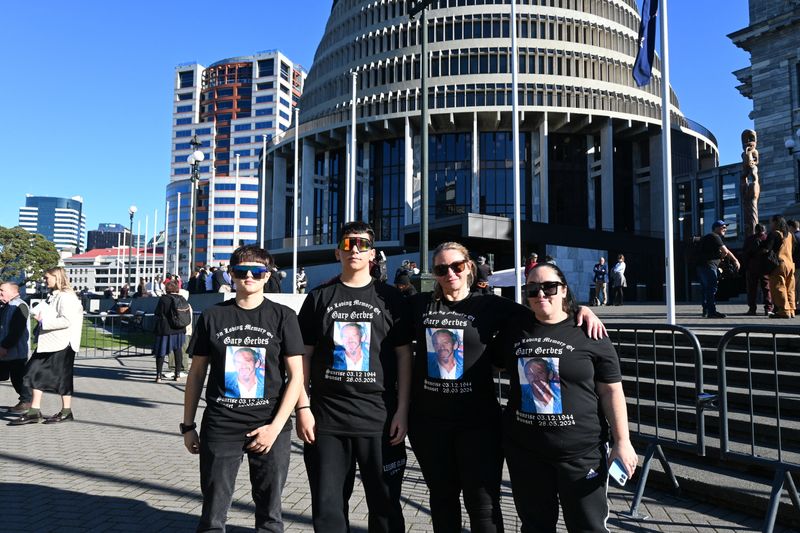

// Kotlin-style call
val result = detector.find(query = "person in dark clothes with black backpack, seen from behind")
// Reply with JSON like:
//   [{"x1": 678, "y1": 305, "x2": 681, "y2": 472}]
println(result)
[{"x1": 153, "y1": 279, "x2": 189, "y2": 383}]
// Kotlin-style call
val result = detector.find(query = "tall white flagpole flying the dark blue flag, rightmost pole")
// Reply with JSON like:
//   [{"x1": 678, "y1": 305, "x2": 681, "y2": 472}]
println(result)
[{"x1": 661, "y1": 0, "x2": 675, "y2": 325}]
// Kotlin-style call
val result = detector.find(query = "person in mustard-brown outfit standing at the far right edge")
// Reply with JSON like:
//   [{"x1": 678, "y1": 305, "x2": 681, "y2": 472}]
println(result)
[{"x1": 764, "y1": 215, "x2": 798, "y2": 318}]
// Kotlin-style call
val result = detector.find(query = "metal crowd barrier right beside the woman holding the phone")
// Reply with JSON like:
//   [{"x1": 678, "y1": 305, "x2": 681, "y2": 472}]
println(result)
[{"x1": 607, "y1": 324, "x2": 716, "y2": 519}]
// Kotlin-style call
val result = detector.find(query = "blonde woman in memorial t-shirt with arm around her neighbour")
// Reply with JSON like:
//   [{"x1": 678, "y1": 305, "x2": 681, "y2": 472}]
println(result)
[{"x1": 409, "y1": 242, "x2": 605, "y2": 533}]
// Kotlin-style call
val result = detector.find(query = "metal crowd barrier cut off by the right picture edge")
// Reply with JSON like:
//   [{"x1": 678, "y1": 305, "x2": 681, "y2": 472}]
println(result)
[{"x1": 717, "y1": 326, "x2": 800, "y2": 533}]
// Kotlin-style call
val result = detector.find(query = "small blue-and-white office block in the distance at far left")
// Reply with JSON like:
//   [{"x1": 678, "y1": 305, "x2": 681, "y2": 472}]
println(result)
[{"x1": 19, "y1": 194, "x2": 86, "y2": 253}]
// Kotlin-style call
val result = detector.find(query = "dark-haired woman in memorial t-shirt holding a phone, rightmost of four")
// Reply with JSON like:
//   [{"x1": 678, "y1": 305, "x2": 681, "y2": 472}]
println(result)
[{"x1": 491, "y1": 264, "x2": 638, "y2": 533}]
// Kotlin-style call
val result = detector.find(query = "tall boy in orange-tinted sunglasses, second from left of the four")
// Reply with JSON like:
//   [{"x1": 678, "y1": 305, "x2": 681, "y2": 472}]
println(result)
[{"x1": 296, "y1": 222, "x2": 412, "y2": 533}]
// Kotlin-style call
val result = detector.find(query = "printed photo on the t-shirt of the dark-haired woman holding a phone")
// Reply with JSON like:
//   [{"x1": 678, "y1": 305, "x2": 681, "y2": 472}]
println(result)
[{"x1": 518, "y1": 357, "x2": 562, "y2": 415}]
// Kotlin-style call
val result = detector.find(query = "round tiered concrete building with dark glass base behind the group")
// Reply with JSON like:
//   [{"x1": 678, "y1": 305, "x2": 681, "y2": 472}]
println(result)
[{"x1": 262, "y1": 0, "x2": 718, "y2": 300}]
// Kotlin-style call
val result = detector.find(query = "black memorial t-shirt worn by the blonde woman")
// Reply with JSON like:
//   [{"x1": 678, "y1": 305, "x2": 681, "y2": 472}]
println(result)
[{"x1": 411, "y1": 293, "x2": 526, "y2": 428}]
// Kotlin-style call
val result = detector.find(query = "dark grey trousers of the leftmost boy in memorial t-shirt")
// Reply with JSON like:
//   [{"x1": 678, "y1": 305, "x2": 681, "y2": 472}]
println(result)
[{"x1": 197, "y1": 430, "x2": 292, "y2": 533}]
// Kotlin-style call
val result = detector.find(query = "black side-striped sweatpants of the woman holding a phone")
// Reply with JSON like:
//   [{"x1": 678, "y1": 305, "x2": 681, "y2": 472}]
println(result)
[{"x1": 505, "y1": 442, "x2": 608, "y2": 533}]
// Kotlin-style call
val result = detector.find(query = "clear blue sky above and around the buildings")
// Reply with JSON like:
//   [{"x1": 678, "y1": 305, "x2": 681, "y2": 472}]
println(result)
[{"x1": 0, "y1": 0, "x2": 752, "y2": 231}]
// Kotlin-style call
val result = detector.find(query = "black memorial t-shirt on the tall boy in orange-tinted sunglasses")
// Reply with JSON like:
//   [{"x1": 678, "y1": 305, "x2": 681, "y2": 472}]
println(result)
[{"x1": 299, "y1": 278, "x2": 411, "y2": 436}]
